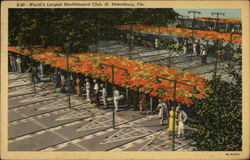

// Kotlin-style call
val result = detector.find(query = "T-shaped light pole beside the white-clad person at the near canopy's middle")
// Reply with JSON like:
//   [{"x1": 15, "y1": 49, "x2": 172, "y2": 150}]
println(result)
[{"x1": 97, "y1": 63, "x2": 128, "y2": 129}]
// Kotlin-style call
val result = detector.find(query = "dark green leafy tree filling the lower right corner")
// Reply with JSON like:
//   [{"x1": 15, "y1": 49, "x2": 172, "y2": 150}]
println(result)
[{"x1": 187, "y1": 59, "x2": 242, "y2": 151}]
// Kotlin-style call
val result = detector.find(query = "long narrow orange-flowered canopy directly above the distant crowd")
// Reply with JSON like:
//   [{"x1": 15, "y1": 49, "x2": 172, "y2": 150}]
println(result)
[{"x1": 116, "y1": 25, "x2": 241, "y2": 44}]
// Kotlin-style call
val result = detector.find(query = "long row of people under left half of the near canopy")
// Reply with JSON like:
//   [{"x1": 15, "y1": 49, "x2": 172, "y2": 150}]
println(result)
[{"x1": 9, "y1": 53, "x2": 128, "y2": 111}]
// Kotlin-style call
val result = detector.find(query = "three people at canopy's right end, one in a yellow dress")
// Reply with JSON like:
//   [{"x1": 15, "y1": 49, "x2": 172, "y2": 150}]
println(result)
[{"x1": 155, "y1": 99, "x2": 188, "y2": 137}]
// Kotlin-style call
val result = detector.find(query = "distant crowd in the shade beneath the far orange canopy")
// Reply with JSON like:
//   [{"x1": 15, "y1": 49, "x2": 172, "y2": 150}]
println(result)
[{"x1": 115, "y1": 29, "x2": 241, "y2": 66}]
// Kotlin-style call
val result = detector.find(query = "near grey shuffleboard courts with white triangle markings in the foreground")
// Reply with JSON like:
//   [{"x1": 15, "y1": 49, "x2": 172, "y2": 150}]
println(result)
[{"x1": 8, "y1": 73, "x2": 190, "y2": 151}]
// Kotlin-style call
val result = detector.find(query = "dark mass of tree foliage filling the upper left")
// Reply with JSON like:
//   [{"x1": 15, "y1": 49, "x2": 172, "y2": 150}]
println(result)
[{"x1": 9, "y1": 9, "x2": 177, "y2": 53}]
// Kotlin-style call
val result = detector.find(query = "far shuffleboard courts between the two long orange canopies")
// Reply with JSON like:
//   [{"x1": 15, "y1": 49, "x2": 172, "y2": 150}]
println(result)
[{"x1": 90, "y1": 41, "x2": 237, "y2": 81}]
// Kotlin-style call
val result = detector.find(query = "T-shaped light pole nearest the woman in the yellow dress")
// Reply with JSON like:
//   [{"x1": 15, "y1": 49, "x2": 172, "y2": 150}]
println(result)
[{"x1": 156, "y1": 76, "x2": 199, "y2": 151}]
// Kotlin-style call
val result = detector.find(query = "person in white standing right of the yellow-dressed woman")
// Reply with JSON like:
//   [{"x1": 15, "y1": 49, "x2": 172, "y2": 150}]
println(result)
[{"x1": 176, "y1": 106, "x2": 188, "y2": 137}]
